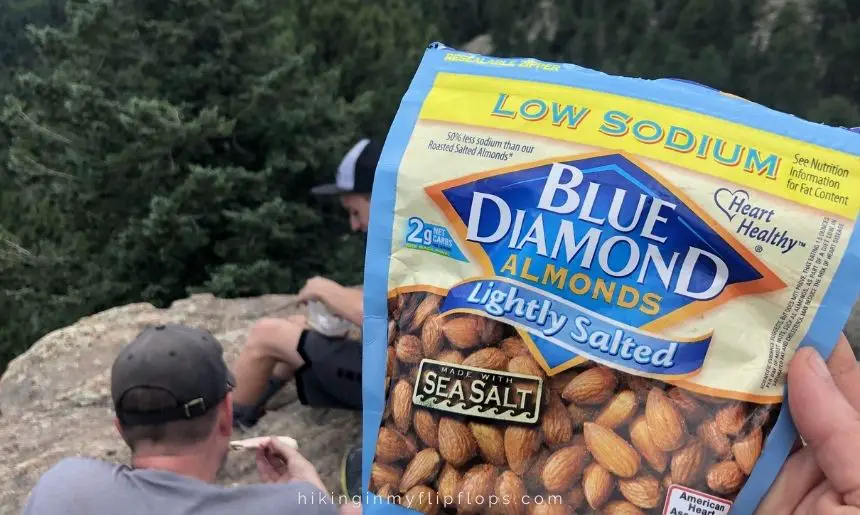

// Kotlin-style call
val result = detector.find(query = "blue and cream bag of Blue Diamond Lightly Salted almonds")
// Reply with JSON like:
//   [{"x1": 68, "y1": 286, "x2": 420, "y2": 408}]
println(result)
[{"x1": 363, "y1": 44, "x2": 860, "y2": 515}]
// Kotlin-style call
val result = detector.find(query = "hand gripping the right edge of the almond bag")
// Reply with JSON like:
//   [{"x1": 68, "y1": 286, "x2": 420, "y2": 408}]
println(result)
[{"x1": 756, "y1": 334, "x2": 860, "y2": 515}]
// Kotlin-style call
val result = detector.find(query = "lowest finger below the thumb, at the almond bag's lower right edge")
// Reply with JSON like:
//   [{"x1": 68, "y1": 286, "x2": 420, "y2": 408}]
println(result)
[{"x1": 756, "y1": 447, "x2": 824, "y2": 515}]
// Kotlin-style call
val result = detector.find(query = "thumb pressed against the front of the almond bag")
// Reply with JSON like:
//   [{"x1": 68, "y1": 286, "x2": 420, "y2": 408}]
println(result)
[{"x1": 788, "y1": 347, "x2": 860, "y2": 495}]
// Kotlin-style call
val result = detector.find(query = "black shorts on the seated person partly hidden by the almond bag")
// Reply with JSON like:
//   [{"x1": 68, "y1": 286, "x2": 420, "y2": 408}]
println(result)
[{"x1": 295, "y1": 329, "x2": 362, "y2": 411}]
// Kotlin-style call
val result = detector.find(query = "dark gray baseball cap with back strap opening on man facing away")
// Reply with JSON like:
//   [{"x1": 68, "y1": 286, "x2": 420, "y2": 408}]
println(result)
[{"x1": 111, "y1": 324, "x2": 236, "y2": 426}]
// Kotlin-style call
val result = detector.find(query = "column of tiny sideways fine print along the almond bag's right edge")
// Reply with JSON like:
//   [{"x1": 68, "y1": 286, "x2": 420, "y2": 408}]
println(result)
[{"x1": 761, "y1": 217, "x2": 845, "y2": 388}]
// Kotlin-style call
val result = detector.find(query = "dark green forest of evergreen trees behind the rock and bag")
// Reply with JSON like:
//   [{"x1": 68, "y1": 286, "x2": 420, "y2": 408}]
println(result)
[{"x1": 0, "y1": 0, "x2": 860, "y2": 371}]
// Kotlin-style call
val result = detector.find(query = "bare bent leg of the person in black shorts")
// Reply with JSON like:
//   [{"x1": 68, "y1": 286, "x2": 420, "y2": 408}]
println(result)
[{"x1": 233, "y1": 315, "x2": 306, "y2": 406}]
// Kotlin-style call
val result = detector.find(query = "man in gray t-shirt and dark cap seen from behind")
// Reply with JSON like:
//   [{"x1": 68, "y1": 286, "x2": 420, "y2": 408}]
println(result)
[{"x1": 22, "y1": 325, "x2": 361, "y2": 515}]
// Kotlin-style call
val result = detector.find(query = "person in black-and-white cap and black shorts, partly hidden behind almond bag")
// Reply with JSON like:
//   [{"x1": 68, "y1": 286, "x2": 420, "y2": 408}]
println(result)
[{"x1": 228, "y1": 139, "x2": 382, "y2": 495}]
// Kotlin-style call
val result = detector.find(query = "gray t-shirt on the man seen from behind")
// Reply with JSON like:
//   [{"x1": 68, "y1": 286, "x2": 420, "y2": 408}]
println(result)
[{"x1": 22, "y1": 458, "x2": 338, "y2": 515}]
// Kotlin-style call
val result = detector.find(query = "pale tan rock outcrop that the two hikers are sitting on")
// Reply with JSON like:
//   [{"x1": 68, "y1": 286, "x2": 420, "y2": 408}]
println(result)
[{"x1": 0, "y1": 295, "x2": 361, "y2": 515}]
